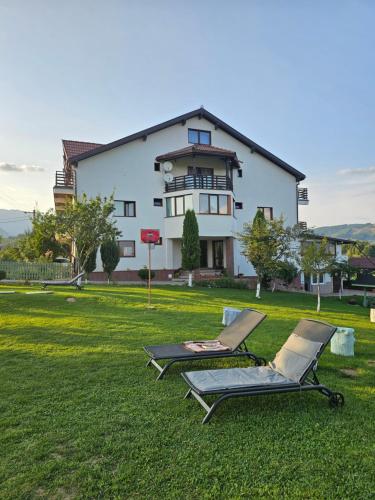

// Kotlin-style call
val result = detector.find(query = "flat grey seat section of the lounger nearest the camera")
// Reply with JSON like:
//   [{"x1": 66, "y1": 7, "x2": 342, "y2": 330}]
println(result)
[{"x1": 184, "y1": 366, "x2": 295, "y2": 393}]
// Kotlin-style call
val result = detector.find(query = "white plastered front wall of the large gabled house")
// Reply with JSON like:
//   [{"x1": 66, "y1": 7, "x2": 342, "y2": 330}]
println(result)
[{"x1": 77, "y1": 118, "x2": 298, "y2": 275}]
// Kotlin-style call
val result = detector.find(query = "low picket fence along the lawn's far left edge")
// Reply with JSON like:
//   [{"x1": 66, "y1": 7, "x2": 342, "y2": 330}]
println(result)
[{"x1": 0, "y1": 260, "x2": 72, "y2": 281}]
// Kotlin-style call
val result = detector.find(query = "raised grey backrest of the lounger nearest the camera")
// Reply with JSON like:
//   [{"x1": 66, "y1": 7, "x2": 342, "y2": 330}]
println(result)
[{"x1": 270, "y1": 333, "x2": 323, "y2": 382}]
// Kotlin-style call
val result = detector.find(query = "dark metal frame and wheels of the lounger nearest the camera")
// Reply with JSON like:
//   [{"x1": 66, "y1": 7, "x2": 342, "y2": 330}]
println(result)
[{"x1": 181, "y1": 322, "x2": 345, "y2": 424}]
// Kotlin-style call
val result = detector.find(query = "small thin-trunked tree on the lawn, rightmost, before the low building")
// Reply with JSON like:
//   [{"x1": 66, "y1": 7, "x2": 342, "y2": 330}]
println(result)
[{"x1": 300, "y1": 238, "x2": 334, "y2": 312}]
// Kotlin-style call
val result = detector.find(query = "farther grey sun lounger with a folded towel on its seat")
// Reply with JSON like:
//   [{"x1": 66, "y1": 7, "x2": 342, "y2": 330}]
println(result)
[{"x1": 144, "y1": 309, "x2": 266, "y2": 380}]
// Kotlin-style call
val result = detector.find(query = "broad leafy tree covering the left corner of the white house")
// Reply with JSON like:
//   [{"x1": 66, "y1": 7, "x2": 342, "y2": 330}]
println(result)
[{"x1": 57, "y1": 194, "x2": 121, "y2": 270}]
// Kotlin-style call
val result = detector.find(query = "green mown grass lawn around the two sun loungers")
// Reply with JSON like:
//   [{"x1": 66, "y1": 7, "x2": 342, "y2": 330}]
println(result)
[{"x1": 0, "y1": 285, "x2": 375, "y2": 499}]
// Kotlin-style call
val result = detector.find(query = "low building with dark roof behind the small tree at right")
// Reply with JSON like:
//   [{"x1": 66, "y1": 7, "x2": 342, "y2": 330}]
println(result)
[{"x1": 300, "y1": 235, "x2": 355, "y2": 294}]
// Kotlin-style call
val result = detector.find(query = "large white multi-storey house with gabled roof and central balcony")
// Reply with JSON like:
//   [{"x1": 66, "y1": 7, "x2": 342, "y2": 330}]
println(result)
[{"x1": 54, "y1": 108, "x2": 308, "y2": 281}]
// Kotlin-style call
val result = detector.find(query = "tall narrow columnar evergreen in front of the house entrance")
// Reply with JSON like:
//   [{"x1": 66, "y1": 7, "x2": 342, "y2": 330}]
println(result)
[{"x1": 181, "y1": 210, "x2": 201, "y2": 287}]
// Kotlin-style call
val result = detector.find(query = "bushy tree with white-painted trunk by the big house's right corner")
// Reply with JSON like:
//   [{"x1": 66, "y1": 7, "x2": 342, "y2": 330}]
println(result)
[{"x1": 238, "y1": 210, "x2": 297, "y2": 299}]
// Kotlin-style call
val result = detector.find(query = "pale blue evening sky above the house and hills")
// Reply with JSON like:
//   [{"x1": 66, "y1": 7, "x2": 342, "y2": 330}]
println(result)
[{"x1": 0, "y1": 0, "x2": 375, "y2": 226}]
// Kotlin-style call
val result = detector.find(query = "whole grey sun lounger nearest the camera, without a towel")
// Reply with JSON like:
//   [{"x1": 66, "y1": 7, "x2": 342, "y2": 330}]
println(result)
[{"x1": 182, "y1": 319, "x2": 344, "y2": 424}]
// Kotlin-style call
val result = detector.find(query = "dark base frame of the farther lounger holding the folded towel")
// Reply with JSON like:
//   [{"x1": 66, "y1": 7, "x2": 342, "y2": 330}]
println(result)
[{"x1": 144, "y1": 342, "x2": 267, "y2": 380}]
